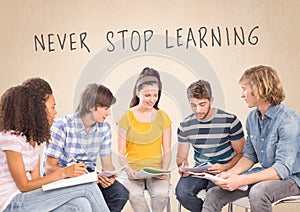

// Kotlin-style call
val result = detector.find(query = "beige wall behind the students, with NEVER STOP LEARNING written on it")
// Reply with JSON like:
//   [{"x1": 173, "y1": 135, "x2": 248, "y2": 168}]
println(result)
[{"x1": 0, "y1": 0, "x2": 300, "y2": 210}]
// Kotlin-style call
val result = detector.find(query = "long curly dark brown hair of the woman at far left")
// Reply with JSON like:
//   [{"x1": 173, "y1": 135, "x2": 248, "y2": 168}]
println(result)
[{"x1": 0, "y1": 85, "x2": 50, "y2": 145}]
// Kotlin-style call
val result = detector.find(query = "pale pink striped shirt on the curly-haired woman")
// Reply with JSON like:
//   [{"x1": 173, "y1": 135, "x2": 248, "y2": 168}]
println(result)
[{"x1": 0, "y1": 132, "x2": 40, "y2": 211}]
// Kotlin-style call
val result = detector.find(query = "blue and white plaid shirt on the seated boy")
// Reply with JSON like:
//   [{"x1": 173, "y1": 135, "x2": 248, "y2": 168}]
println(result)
[{"x1": 47, "y1": 113, "x2": 111, "y2": 168}]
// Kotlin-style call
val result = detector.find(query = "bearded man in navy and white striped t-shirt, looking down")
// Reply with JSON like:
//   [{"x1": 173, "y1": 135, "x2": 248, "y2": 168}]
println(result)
[{"x1": 176, "y1": 80, "x2": 245, "y2": 211}]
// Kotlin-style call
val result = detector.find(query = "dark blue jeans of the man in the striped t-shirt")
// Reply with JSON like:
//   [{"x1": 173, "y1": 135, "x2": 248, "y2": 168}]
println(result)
[{"x1": 176, "y1": 176, "x2": 215, "y2": 212}]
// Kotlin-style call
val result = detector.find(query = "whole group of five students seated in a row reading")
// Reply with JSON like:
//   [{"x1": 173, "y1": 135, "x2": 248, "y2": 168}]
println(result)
[{"x1": 0, "y1": 66, "x2": 300, "y2": 212}]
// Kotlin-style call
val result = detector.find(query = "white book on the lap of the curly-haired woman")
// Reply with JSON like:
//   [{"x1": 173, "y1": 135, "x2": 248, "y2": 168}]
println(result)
[{"x1": 42, "y1": 172, "x2": 98, "y2": 191}]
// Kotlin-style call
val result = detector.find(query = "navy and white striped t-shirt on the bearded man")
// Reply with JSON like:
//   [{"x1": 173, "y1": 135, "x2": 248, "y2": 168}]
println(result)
[{"x1": 177, "y1": 109, "x2": 244, "y2": 165}]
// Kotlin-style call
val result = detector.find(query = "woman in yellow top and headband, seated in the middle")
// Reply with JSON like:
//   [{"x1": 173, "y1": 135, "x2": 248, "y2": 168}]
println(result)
[{"x1": 118, "y1": 68, "x2": 171, "y2": 212}]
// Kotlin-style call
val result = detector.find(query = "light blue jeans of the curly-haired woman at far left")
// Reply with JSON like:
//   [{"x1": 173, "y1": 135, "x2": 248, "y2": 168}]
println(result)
[{"x1": 4, "y1": 183, "x2": 109, "y2": 212}]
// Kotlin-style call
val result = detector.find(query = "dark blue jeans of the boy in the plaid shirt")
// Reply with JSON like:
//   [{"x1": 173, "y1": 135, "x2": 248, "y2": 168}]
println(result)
[{"x1": 98, "y1": 180, "x2": 129, "y2": 212}]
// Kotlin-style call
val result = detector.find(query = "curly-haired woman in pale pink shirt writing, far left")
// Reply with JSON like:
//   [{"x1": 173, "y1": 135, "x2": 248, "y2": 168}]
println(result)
[{"x1": 0, "y1": 81, "x2": 109, "y2": 212}]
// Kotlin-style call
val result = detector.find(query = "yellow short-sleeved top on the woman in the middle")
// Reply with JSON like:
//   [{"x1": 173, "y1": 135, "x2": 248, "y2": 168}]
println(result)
[{"x1": 118, "y1": 110, "x2": 171, "y2": 170}]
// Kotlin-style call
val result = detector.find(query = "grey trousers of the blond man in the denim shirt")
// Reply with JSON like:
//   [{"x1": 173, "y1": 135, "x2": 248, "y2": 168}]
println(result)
[{"x1": 202, "y1": 179, "x2": 300, "y2": 212}]
